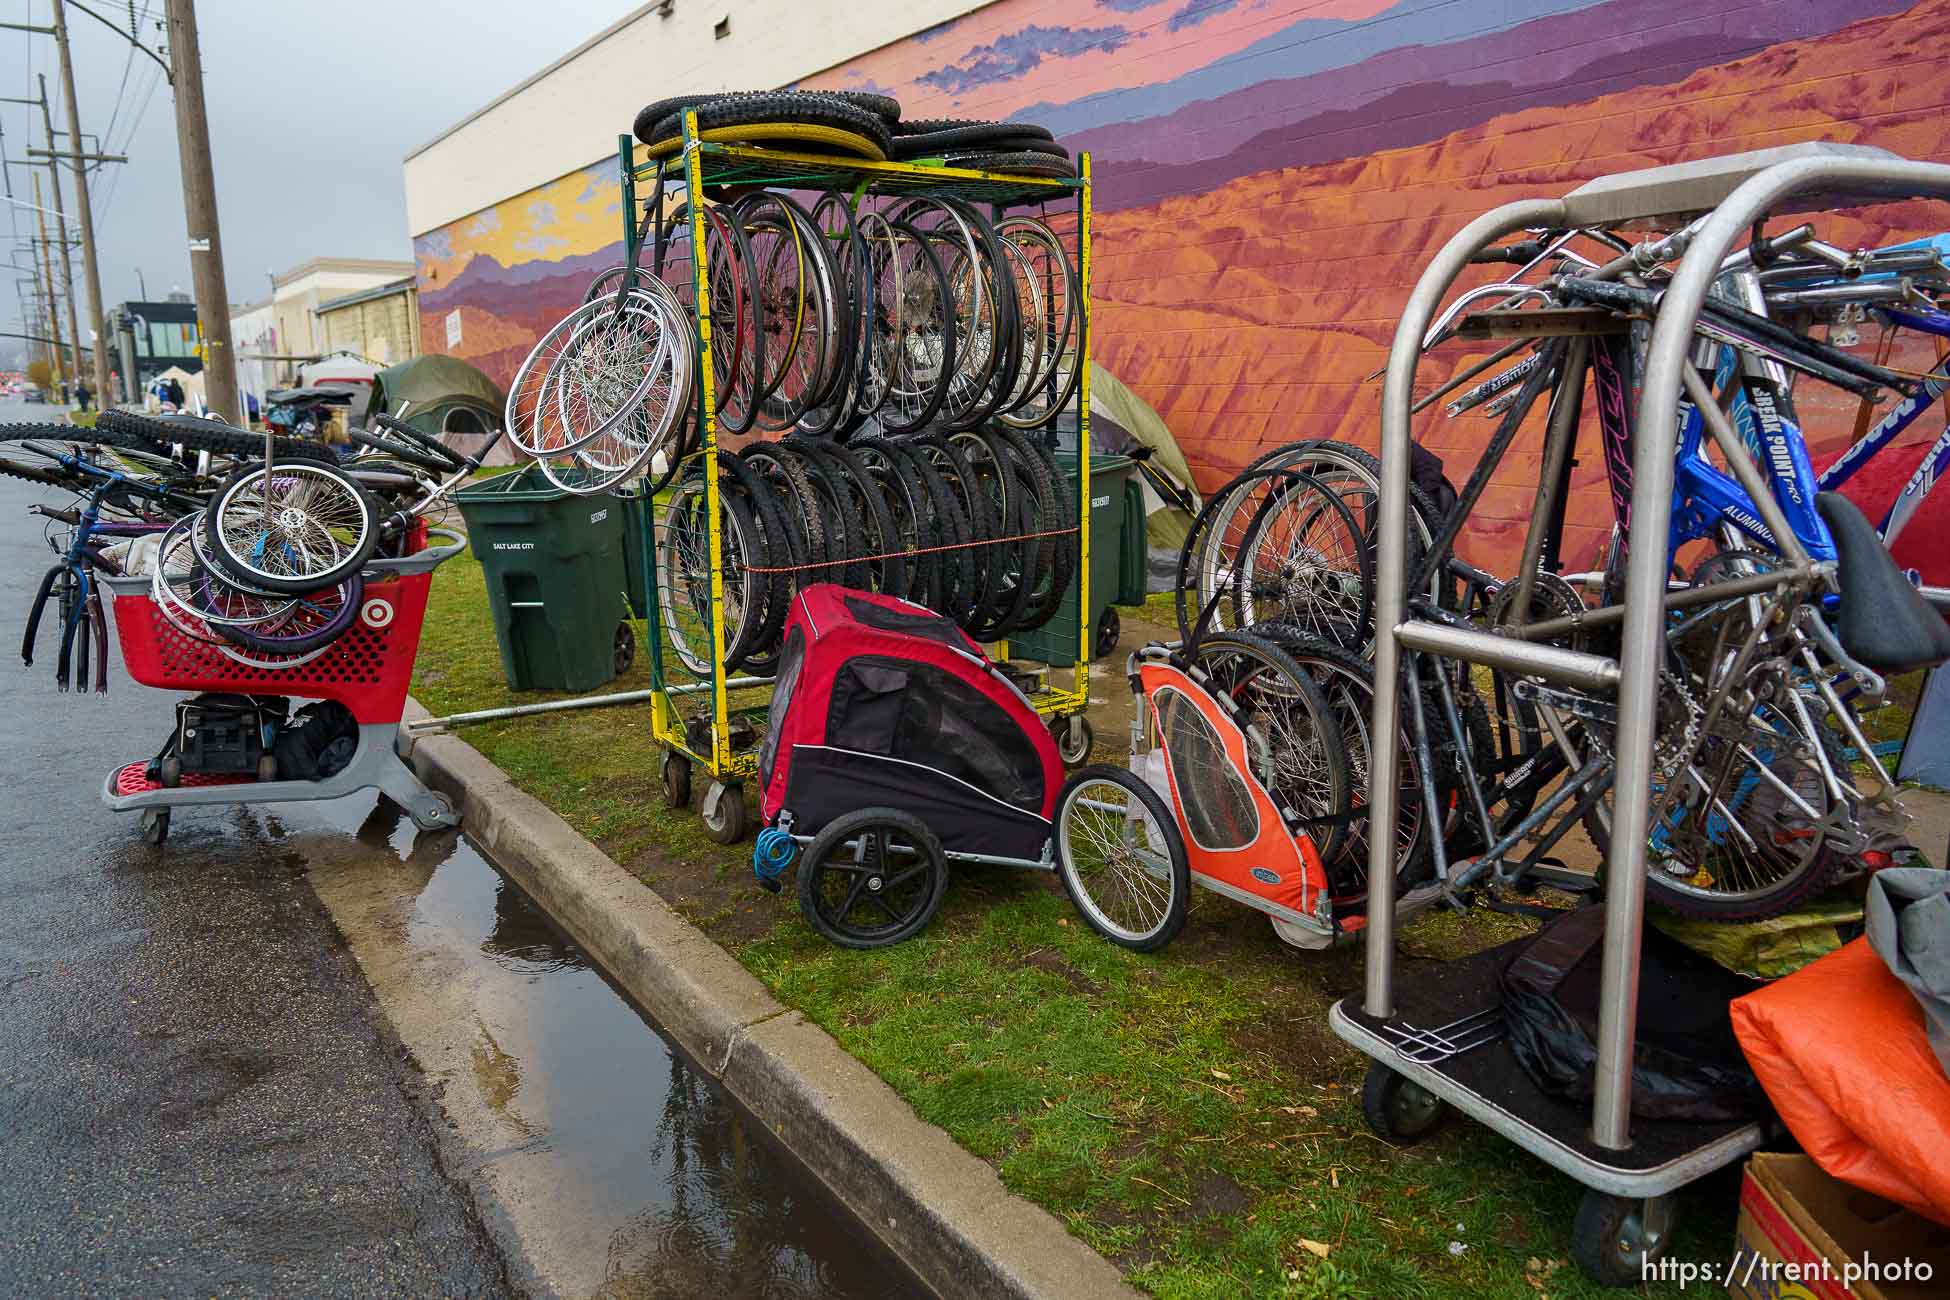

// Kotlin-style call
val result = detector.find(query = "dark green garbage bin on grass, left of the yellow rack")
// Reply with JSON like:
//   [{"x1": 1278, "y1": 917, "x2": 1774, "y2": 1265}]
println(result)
[{"x1": 454, "y1": 468, "x2": 636, "y2": 692}]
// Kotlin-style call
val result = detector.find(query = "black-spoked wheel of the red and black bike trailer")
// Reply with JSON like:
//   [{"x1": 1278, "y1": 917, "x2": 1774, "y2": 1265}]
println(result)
[{"x1": 800, "y1": 809, "x2": 948, "y2": 947}]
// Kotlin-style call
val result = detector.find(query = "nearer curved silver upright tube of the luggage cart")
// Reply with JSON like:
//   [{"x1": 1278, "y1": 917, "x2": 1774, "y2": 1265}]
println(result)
[{"x1": 1614, "y1": 158, "x2": 1950, "y2": 1150}]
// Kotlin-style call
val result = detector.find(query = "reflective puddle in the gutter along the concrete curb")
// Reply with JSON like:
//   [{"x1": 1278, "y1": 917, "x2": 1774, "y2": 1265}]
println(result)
[{"x1": 397, "y1": 830, "x2": 926, "y2": 1300}]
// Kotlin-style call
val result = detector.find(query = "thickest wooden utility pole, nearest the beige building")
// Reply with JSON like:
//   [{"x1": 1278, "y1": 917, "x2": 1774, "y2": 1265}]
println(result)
[{"x1": 161, "y1": 0, "x2": 244, "y2": 425}]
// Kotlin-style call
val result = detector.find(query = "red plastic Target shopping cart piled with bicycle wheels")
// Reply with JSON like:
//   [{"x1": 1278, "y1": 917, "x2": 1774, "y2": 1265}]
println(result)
[{"x1": 101, "y1": 528, "x2": 466, "y2": 844}]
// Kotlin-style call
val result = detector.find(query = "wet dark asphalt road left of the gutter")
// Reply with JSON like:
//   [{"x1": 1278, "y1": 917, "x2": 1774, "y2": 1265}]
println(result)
[{"x1": 0, "y1": 456, "x2": 511, "y2": 1296}]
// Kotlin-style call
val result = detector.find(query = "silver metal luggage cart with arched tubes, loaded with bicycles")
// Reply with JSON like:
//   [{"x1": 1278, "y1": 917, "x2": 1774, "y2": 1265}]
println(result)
[{"x1": 1330, "y1": 144, "x2": 1950, "y2": 1284}]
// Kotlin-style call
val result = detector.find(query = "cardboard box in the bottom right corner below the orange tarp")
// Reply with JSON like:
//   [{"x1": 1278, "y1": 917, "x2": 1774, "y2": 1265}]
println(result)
[{"x1": 1726, "y1": 1152, "x2": 1950, "y2": 1300}]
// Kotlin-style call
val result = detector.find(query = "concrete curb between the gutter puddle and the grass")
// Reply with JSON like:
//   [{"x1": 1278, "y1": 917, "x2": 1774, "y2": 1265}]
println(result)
[{"x1": 408, "y1": 702, "x2": 1137, "y2": 1300}]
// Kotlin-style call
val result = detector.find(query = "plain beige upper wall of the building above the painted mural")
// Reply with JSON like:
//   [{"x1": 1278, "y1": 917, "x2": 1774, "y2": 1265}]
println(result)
[{"x1": 406, "y1": 0, "x2": 991, "y2": 236}]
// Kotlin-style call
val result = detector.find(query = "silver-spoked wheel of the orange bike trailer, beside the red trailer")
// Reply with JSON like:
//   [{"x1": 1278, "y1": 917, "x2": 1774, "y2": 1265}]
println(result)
[{"x1": 1055, "y1": 764, "x2": 1191, "y2": 953}]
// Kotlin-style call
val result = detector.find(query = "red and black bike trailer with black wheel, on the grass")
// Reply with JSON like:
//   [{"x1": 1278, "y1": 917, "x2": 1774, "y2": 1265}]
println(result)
[{"x1": 753, "y1": 583, "x2": 1063, "y2": 947}]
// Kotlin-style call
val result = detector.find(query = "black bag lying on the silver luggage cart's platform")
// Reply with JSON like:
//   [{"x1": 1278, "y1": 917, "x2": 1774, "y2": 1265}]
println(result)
[{"x1": 1503, "y1": 906, "x2": 1769, "y2": 1123}]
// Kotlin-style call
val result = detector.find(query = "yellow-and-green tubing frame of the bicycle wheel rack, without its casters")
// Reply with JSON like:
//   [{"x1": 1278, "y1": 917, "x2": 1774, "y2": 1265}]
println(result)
[{"x1": 631, "y1": 129, "x2": 1094, "y2": 780}]
